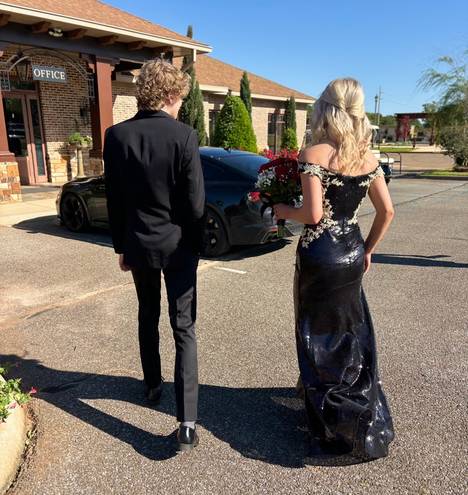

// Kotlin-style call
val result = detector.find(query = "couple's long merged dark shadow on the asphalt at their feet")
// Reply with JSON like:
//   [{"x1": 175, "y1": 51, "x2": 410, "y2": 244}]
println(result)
[{"x1": 0, "y1": 355, "x2": 307, "y2": 468}]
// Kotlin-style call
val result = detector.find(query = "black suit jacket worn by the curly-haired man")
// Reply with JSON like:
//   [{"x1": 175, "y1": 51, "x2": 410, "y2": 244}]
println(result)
[{"x1": 104, "y1": 110, "x2": 205, "y2": 268}]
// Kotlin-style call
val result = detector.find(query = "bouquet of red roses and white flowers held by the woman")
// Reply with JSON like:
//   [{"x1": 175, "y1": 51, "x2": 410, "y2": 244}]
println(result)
[{"x1": 256, "y1": 151, "x2": 302, "y2": 237}]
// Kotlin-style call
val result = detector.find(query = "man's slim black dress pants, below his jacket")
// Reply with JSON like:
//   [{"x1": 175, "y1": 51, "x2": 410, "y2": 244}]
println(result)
[{"x1": 132, "y1": 250, "x2": 199, "y2": 421}]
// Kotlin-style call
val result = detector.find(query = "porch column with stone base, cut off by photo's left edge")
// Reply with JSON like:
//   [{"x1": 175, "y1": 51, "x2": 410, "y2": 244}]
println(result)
[{"x1": 0, "y1": 89, "x2": 21, "y2": 203}]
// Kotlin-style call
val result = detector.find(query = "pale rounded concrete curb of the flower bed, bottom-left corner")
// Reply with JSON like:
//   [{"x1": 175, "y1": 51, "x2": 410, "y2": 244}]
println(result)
[{"x1": 0, "y1": 377, "x2": 28, "y2": 494}]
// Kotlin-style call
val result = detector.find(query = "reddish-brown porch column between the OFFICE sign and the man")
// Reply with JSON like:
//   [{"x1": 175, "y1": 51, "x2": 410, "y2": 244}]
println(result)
[{"x1": 90, "y1": 57, "x2": 115, "y2": 163}]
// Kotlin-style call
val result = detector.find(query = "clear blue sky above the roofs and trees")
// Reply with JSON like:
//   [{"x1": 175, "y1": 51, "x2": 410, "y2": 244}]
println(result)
[{"x1": 106, "y1": 0, "x2": 468, "y2": 115}]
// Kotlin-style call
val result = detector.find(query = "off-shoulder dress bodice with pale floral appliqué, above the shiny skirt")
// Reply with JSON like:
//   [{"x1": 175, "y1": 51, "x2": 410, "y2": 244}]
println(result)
[{"x1": 299, "y1": 162, "x2": 385, "y2": 248}]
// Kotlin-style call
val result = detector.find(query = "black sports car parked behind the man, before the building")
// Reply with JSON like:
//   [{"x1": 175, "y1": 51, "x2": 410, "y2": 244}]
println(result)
[{"x1": 56, "y1": 147, "x2": 277, "y2": 256}]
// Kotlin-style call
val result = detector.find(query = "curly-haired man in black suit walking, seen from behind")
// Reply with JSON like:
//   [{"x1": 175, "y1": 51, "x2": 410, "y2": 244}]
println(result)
[{"x1": 104, "y1": 60, "x2": 205, "y2": 450}]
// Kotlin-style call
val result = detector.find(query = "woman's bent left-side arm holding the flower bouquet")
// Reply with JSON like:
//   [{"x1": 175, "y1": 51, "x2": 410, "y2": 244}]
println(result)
[{"x1": 273, "y1": 174, "x2": 323, "y2": 225}]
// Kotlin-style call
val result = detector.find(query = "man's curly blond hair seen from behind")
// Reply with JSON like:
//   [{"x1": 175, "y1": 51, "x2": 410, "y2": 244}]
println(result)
[{"x1": 136, "y1": 58, "x2": 190, "y2": 111}]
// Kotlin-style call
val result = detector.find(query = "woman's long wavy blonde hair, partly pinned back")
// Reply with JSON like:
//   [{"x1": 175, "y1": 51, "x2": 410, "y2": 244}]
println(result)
[{"x1": 311, "y1": 78, "x2": 372, "y2": 173}]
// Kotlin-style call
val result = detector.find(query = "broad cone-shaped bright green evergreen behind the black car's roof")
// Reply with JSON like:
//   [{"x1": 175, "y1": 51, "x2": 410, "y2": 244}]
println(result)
[{"x1": 214, "y1": 96, "x2": 257, "y2": 153}]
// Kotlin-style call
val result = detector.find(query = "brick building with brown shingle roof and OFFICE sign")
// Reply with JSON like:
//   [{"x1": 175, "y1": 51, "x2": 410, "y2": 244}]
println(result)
[{"x1": 0, "y1": 0, "x2": 313, "y2": 202}]
